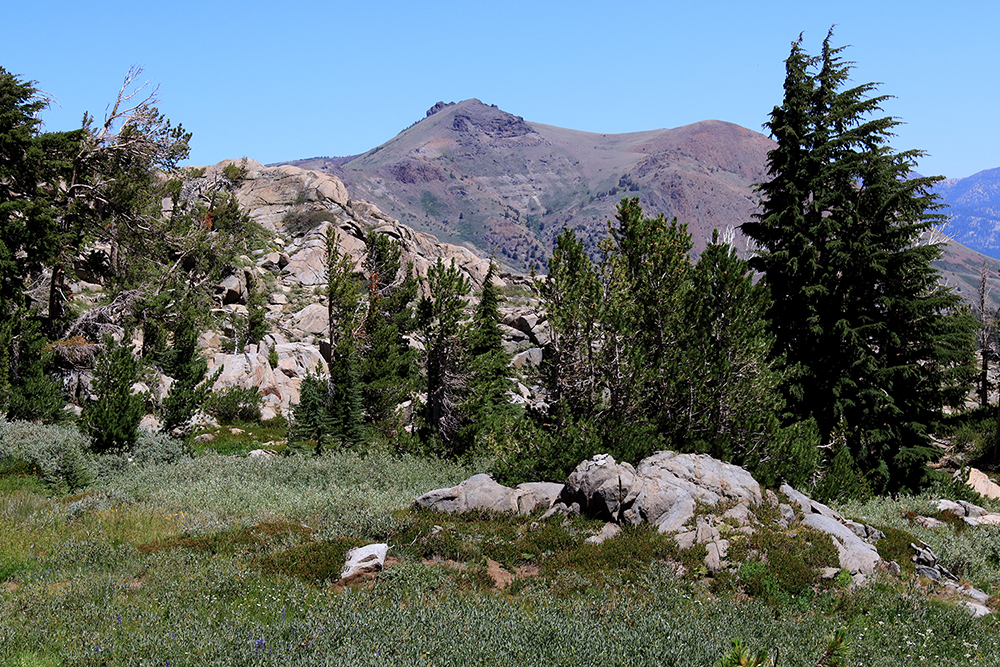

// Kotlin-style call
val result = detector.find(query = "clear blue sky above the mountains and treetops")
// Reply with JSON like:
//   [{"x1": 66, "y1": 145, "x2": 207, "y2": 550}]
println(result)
[{"x1": 0, "y1": 0, "x2": 1000, "y2": 177}]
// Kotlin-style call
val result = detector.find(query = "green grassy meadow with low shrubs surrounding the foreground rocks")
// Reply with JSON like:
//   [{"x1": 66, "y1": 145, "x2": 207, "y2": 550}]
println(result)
[{"x1": 0, "y1": 446, "x2": 1000, "y2": 666}]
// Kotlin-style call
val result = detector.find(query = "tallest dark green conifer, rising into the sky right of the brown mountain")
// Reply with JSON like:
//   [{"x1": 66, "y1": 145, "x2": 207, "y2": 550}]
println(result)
[{"x1": 743, "y1": 28, "x2": 973, "y2": 492}]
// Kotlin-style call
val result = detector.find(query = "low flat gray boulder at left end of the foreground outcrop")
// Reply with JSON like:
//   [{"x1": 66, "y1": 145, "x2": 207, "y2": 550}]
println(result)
[{"x1": 413, "y1": 474, "x2": 563, "y2": 514}]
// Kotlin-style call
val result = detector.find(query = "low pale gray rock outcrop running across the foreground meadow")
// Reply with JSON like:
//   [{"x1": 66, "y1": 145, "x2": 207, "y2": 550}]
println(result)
[{"x1": 414, "y1": 451, "x2": 1000, "y2": 615}]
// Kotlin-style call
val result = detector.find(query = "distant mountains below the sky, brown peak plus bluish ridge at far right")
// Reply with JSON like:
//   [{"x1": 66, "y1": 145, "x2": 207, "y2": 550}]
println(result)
[{"x1": 282, "y1": 99, "x2": 1000, "y2": 306}]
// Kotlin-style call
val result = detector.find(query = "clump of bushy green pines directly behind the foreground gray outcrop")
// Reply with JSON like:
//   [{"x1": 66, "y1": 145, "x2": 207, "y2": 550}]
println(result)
[{"x1": 540, "y1": 198, "x2": 784, "y2": 472}]
